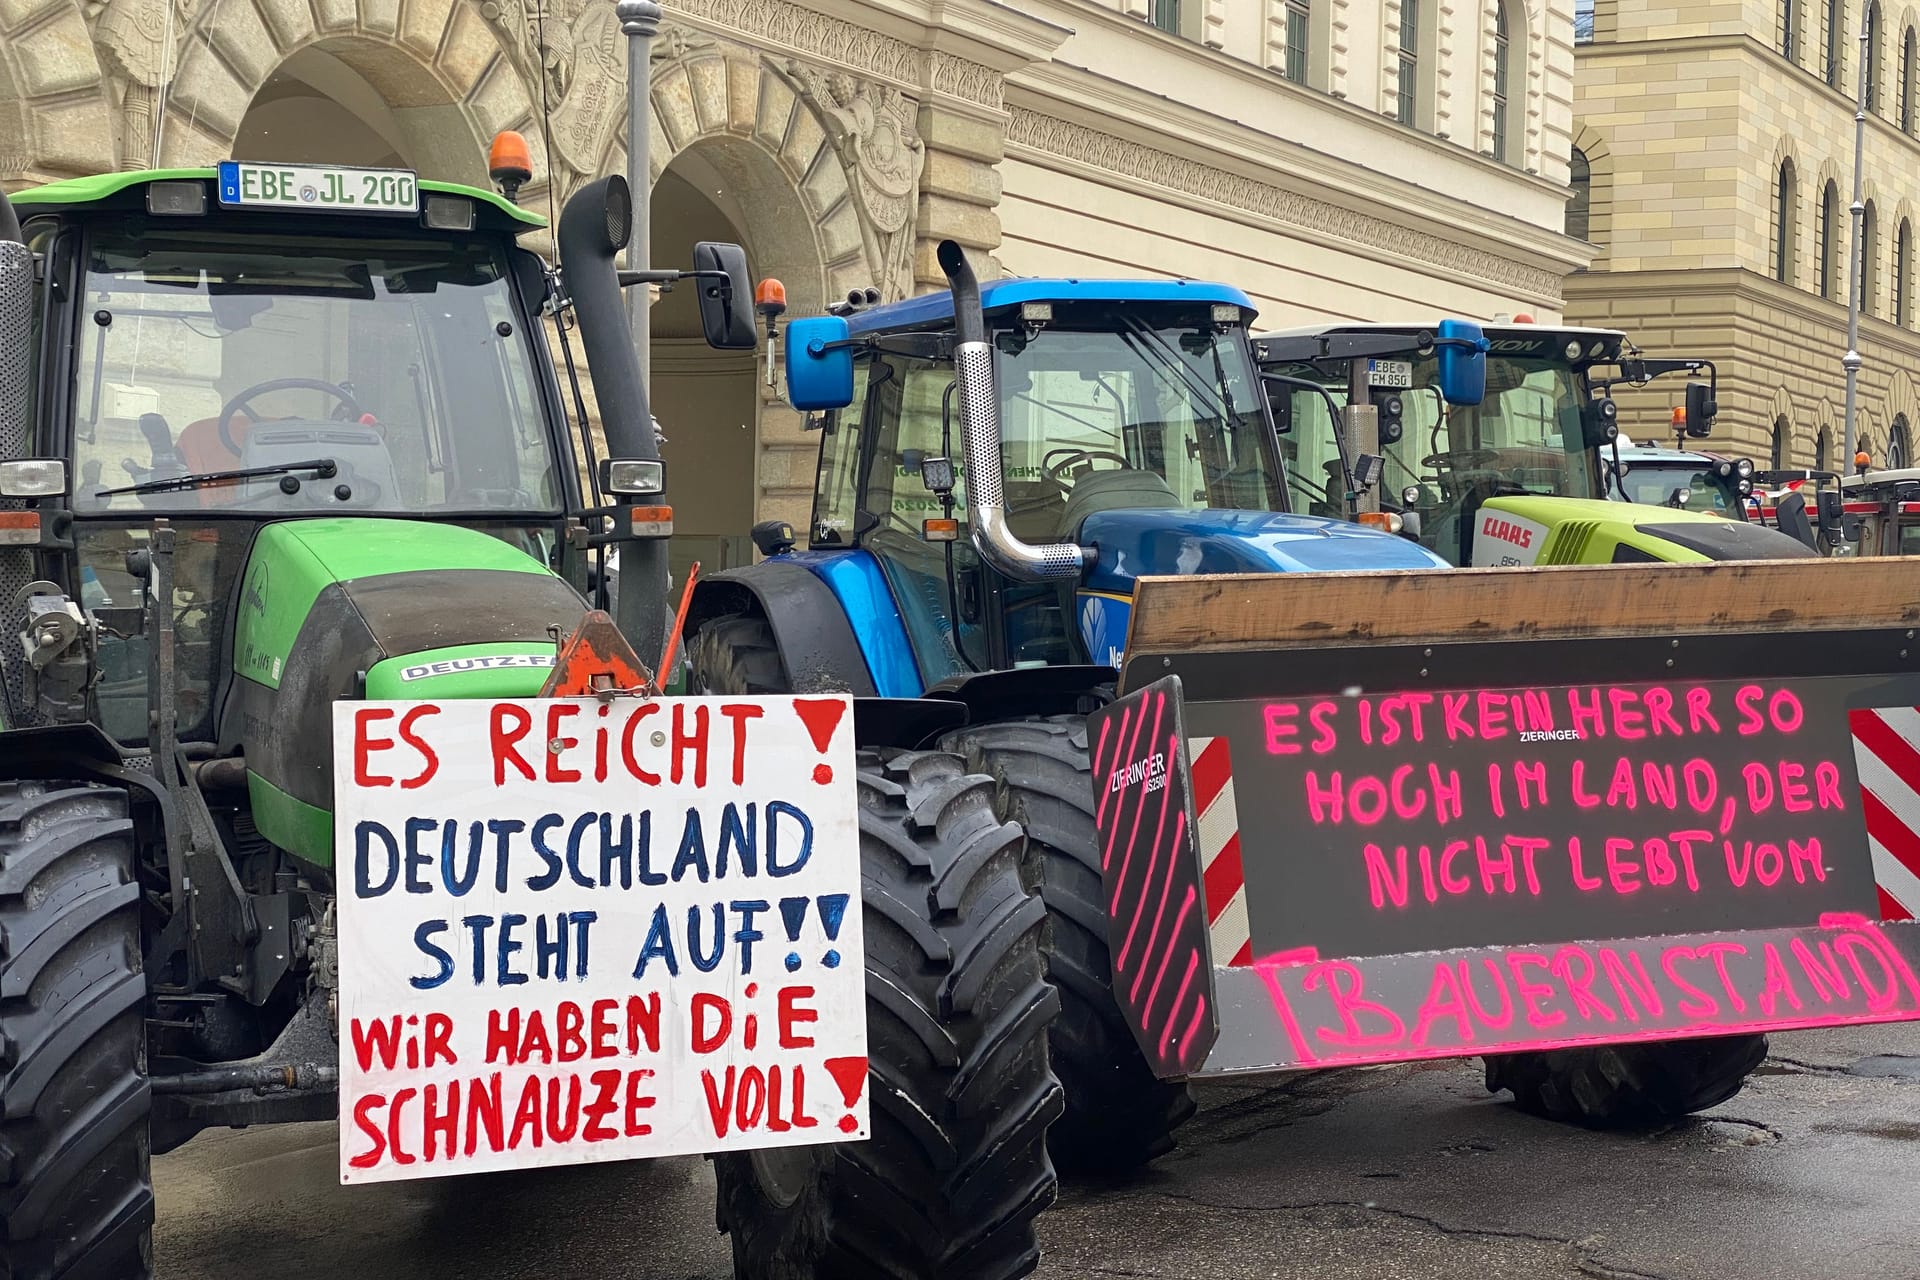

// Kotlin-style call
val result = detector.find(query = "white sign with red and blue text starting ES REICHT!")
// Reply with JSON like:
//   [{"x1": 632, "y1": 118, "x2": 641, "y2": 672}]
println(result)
[{"x1": 334, "y1": 697, "x2": 868, "y2": 1182}]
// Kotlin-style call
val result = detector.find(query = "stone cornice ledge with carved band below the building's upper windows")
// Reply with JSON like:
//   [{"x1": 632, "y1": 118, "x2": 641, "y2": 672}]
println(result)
[{"x1": 1008, "y1": 92, "x2": 1586, "y2": 309}]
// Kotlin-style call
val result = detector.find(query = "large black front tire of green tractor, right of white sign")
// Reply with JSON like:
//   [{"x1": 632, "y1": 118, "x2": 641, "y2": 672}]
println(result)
[{"x1": 714, "y1": 752, "x2": 1062, "y2": 1280}]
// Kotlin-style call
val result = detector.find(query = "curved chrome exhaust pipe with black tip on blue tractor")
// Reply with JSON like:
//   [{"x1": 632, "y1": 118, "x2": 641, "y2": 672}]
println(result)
[{"x1": 935, "y1": 240, "x2": 1087, "y2": 581}]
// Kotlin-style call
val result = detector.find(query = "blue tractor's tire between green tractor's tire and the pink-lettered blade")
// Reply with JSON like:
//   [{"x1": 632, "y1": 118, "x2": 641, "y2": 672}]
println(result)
[{"x1": 941, "y1": 716, "x2": 1194, "y2": 1173}]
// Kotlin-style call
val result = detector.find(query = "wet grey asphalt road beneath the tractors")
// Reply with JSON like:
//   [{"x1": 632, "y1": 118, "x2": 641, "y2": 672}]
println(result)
[{"x1": 156, "y1": 1025, "x2": 1920, "y2": 1280}]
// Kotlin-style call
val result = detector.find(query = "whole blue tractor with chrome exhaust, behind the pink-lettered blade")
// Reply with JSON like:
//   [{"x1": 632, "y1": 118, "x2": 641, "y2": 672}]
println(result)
[{"x1": 687, "y1": 244, "x2": 1459, "y2": 1171}]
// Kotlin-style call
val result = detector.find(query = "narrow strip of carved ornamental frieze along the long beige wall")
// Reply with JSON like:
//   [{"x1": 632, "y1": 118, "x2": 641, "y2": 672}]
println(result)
[{"x1": 1006, "y1": 107, "x2": 1561, "y2": 297}]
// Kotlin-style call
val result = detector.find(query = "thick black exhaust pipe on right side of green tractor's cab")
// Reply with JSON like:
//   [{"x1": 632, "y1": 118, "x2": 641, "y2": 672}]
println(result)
[{"x1": 559, "y1": 175, "x2": 668, "y2": 660}]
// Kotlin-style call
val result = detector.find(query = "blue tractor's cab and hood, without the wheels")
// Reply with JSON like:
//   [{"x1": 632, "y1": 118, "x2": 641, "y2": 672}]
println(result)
[{"x1": 756, "y1": 264, "x2": 1438, "y2": 695}]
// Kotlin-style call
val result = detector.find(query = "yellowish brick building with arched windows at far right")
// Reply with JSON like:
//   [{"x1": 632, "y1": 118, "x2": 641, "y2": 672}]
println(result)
[{"x1": 1567, "y1": 0, "x2": 1920, "y2": 466}]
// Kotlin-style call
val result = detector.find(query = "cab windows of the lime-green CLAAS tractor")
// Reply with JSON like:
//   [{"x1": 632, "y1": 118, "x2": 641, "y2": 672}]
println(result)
[{"x1": 1271, "y1": 355, "x2": 1601, "y2": 564}]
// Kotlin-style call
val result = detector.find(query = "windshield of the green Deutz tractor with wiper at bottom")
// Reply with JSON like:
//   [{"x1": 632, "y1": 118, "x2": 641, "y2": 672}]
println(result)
[{"x1": 73, "y1": 232, "x2": 561, "y2": 516}]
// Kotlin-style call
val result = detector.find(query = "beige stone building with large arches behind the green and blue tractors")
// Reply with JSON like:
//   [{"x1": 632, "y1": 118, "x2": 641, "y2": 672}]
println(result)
[{"x1": 0, "y1": 0, "x2": 1590, "y2": 564}]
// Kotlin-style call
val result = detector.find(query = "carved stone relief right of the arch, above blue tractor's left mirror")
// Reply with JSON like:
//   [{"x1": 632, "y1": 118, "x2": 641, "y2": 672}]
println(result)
[{"x1": 781, "y1": 59, "x2": 927, "y2": 297}]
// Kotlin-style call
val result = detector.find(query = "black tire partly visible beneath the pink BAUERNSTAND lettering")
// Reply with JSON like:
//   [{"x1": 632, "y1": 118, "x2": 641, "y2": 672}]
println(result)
[{"x1": 1486, "y1": 1034, "x2": 1766, "y2": 1128}]
